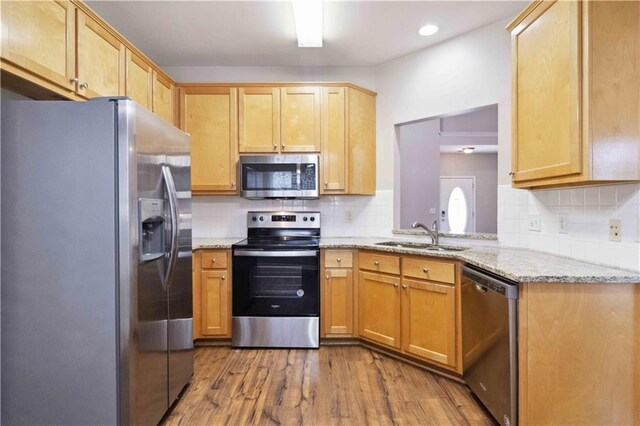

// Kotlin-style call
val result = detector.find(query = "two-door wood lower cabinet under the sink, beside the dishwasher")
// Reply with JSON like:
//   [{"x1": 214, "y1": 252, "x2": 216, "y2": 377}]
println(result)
[{"x1": 357, "y1": 251, "x2": 462, "y2": 373}]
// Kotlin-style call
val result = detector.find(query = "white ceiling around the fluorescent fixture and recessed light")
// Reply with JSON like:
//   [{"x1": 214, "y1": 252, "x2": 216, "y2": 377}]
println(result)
[{"x1": 87, "y1": 0, "x2": 526, "y2": 66}]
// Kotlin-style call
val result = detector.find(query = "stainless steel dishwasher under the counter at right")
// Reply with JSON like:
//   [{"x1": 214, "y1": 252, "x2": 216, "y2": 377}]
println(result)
[{"x1": 462, "y1": 266, "x2": 518, "y2": 426}]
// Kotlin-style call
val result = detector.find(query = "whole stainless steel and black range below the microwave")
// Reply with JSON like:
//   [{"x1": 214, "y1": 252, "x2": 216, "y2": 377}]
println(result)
[{"x1": 232, "y1": 212, "x2": 320, "y2": 348}]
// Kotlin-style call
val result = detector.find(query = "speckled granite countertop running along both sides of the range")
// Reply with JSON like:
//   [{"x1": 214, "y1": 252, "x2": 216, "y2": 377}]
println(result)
[{"x1": 193, "y1": 237, "x2": 640, "y2": 284}]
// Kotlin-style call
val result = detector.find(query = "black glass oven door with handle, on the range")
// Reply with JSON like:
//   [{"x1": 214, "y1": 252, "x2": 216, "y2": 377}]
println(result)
[{"x1": 233, "y1": 249, "x2": 320, "y2": 317}]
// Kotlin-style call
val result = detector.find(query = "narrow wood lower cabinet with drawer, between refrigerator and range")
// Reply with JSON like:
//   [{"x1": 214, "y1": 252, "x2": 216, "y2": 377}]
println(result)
[{"x1": 193, "y1": 250, "x2": 231, "y2": 339}]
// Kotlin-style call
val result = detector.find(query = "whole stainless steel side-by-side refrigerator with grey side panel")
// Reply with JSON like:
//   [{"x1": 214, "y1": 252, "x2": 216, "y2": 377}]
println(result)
[{"x1": 1, "y1": 98, "x2": 193, "y2": 425}]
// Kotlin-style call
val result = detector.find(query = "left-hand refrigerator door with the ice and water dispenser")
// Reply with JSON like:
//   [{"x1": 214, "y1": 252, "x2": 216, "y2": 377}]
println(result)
[{"x1": 117, "y1": 101, "x2": 170, "y2": 425}]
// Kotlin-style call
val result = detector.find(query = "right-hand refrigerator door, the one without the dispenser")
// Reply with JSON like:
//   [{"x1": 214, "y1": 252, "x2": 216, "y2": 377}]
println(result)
[{"x1": 166, "y1": 126, "x2": 193, "y2": 405}]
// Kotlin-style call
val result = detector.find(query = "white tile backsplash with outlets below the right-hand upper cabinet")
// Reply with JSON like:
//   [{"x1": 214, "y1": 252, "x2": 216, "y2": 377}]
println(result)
[{"x1": 498, "y1": 184, "x2": 640, "y2": 271}]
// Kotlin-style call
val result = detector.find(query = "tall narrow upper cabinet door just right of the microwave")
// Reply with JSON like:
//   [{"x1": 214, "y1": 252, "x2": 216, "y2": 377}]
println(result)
[{"x1": 320, "y1": 87, "x2": 348, "y2": 194}]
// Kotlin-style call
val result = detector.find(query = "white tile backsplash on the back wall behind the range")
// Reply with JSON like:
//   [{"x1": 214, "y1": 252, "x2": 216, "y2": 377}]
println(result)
[{"x1": 192, "y1": 190, "x2": 393, "y2": 238}]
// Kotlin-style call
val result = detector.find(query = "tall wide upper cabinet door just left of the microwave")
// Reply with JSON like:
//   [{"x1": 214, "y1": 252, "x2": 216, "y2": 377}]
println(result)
[{"x1": 180, "y1": 87, "x2": 238, "y2": 193}]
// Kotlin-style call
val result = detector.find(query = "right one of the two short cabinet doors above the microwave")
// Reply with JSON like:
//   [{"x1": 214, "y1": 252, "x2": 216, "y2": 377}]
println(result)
[{"x1": 280, "y1": 87, "x2": 320, "y2": 152}]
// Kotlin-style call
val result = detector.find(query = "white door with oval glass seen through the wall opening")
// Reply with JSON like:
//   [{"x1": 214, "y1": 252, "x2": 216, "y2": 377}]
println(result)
[{"x1": 440, "y1": 176, "x2": 476, "y2": 234}]
